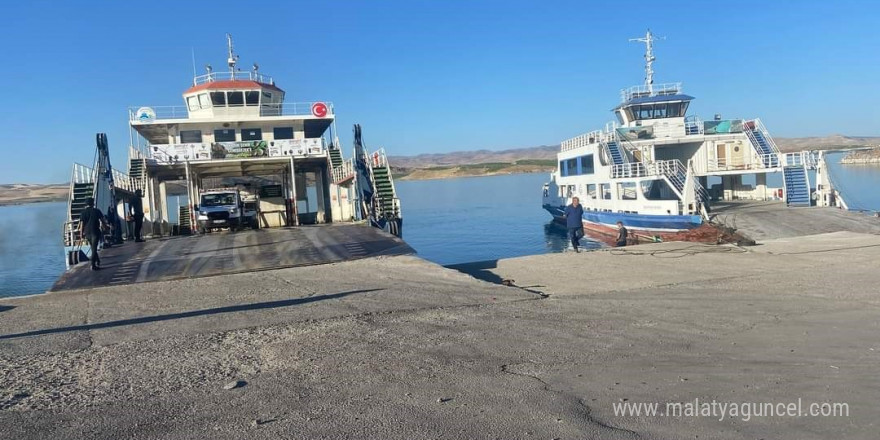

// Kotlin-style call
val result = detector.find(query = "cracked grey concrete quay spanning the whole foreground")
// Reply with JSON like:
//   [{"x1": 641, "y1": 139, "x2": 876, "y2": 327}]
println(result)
[{"x1": 0, "y1": 225, "x2": 880, "y2": 439}]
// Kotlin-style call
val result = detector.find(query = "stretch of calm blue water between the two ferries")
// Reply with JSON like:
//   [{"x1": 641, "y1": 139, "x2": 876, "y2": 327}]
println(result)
[{"x1": 395, "y1": 173, "x2": 601, "y2": 264}]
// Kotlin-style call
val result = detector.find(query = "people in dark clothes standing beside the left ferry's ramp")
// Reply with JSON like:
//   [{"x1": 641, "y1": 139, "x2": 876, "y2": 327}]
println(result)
[{"x1": 79, "y1": 190, "x2": 144, "y2": 270}]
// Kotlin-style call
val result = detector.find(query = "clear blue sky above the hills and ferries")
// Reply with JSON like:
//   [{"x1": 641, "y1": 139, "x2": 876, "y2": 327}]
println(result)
[{"x1": 0, "y1": 0, "x2": 880, "y2": 183}]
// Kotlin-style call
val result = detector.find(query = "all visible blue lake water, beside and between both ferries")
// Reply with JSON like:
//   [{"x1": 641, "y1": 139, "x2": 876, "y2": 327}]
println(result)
[{"x1": 0, "y1": 154, "x2": 880, "y2": 297}]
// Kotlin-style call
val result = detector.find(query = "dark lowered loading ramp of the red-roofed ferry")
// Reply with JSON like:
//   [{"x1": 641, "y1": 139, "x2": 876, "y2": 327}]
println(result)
[{"x1": 49, "y1": 224, "x2": 414, "y2": 292}]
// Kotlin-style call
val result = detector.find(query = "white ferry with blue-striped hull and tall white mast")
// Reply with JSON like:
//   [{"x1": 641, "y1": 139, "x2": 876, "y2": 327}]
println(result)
[{"x1": 543, "y1": 30, "x2": 815, "y2": 241}]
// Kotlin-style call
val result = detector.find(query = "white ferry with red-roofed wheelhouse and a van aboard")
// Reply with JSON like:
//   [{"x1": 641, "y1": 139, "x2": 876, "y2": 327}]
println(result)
[{"x1": 64, "y1": 34, "x2": 402, "y2": 265}]
